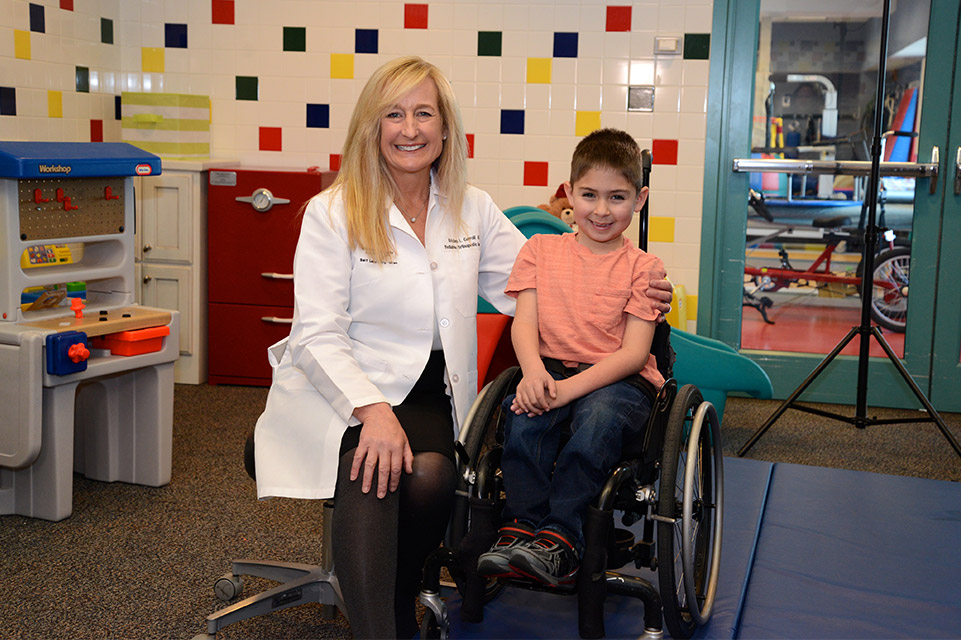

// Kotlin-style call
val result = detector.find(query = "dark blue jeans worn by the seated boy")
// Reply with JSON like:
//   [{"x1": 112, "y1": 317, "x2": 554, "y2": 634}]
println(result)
[{"x1": 501, "y1": 372, "x2": 651, "y2": 555}]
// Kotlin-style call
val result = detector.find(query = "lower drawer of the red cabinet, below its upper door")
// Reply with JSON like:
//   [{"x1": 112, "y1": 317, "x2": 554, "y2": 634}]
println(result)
[{"x1": 207, "y1": 303, "x2": 294, "y2": 386}]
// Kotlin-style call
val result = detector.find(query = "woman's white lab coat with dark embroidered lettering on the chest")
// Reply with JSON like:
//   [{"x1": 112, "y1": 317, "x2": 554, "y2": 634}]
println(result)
[{"x1": 254, "y1": 181, "x2": 525, "y2": 499}]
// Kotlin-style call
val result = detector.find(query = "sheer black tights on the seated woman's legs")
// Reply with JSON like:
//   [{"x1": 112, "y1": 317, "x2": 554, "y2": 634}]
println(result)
[{"x1": 332, "y1": 449, "x2": 457, "y2": 638}]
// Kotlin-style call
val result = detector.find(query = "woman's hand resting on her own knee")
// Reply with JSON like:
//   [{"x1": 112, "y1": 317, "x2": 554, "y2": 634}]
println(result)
[{"x1": 350, "y1": 402, "x2": 414, "y2": 498}]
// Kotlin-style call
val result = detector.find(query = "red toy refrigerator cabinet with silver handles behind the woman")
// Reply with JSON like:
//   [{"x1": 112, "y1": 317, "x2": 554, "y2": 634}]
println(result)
[{"x1": 207, "y1": 168, "x2": 337, "y2": 386}]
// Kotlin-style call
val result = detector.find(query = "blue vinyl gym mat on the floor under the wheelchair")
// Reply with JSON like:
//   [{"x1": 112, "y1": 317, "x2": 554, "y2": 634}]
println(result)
[{"x1": 438, "y1": 458, "x2": 961, "y2": 638}]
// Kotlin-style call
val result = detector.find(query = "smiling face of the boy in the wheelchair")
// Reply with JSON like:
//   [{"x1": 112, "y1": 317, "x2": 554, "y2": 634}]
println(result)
[{"x1": 564, "y1": 167, "x2": 647, "y2": 253}]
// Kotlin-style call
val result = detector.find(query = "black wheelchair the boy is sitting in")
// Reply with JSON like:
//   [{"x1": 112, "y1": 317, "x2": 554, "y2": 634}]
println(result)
[{"x1": 420, "y1": 323, "x2": 724, "y2": 638}]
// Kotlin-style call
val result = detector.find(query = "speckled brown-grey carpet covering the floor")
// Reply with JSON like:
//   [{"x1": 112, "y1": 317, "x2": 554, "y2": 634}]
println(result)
[{"x1": 0, "y1": 385, "x2": 961, "y2": 639}]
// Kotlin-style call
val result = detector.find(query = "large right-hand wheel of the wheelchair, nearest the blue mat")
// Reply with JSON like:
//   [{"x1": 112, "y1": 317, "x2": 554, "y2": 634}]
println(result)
[{"x1": 657, "y1": 385, "x2": 723, "y2": 638}]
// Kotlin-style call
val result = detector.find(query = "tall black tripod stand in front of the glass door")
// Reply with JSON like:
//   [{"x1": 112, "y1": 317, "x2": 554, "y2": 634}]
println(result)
[{"x1": 737, "y1": 0, "x2": 961, "y2": 456}]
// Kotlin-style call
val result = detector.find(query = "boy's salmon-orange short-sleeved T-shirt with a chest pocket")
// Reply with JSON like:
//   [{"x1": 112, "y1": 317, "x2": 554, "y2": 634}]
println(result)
[{"x1": 505, "y1": 233, "x2": 664, "y2": 388}]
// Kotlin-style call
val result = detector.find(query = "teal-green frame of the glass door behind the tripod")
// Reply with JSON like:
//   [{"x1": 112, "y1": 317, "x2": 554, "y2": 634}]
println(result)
[{"x1": 697, "y1": 0, "x2": 961, "y2": 410}]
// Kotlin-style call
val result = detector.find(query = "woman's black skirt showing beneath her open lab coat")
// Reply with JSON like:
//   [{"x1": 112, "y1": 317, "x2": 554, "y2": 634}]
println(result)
[{"x1": 340, "y1": 351, "x2": 457, "y2": 463}]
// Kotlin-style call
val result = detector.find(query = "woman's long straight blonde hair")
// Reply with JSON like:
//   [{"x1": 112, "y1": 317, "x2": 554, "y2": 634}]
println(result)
[{"x1": 332, "y1": 56, "x2": 467, "y2": 262}]
